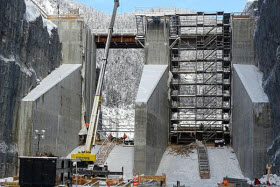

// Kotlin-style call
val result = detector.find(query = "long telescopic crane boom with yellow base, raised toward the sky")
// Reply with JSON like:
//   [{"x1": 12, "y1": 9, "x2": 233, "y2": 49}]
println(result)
[{"x1": 71, "y1": 0, "x2": 119, "y2": 164}]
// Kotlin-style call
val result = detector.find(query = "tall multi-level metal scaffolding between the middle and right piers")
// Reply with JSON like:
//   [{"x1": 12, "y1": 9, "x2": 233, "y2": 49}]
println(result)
[{"x1": 168, "y1": 12, "x2": 231, "y2": 143}]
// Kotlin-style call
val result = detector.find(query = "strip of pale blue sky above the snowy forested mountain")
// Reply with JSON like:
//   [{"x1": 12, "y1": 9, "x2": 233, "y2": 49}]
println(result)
[{"x1": 75, "y1": 0, "x2": 248, "y2": 13}]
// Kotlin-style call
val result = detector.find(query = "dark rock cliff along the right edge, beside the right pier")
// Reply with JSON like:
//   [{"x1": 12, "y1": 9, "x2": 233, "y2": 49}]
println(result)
[{"x1": 255, "y1": 0, "x2": 280, "y2": 174}]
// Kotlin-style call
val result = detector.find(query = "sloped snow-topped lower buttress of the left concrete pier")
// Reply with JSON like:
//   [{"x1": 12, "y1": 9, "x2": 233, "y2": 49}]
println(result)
[{"x1": 17, "y1": 64, "x2": 82, "y2": 156}]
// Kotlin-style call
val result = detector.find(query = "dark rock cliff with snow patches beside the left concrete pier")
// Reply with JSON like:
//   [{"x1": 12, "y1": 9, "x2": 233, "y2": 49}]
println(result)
[{"x1": 0, "y1": 0, "x2": 61, "y2": 178}]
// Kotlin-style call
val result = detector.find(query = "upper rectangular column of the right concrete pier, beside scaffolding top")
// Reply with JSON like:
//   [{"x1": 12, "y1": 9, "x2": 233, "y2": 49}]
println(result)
[{"x1": 232, "y1": 16, "x2": 257, "y2": 65}]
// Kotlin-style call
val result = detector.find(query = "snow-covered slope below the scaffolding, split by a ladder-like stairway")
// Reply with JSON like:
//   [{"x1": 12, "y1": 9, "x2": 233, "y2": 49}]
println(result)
[{"x1": 157, "y1": 147, "x2": 244, "y2": 187}]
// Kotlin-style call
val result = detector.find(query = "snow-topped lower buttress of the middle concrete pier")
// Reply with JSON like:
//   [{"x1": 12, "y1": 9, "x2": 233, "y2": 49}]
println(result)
[{"x1": 134, "y1": 65, "x2": 169, "y2": 175}]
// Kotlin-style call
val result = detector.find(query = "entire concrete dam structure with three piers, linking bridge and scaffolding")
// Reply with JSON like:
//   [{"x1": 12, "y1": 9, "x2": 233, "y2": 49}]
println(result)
[{"x1": 0, "y1": 0, "x2": 273, "y2": 183}]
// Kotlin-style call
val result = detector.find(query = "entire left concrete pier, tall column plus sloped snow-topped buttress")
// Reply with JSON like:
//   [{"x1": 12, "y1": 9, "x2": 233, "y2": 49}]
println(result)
[{"x1": 14, "y1": 17, "x2": 96, "y2": 168}]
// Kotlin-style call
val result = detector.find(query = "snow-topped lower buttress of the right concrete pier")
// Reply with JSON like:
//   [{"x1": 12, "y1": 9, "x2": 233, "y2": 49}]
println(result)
[{"x1": 232, "y1": 64, "x2": 272, "y2": 179}]
